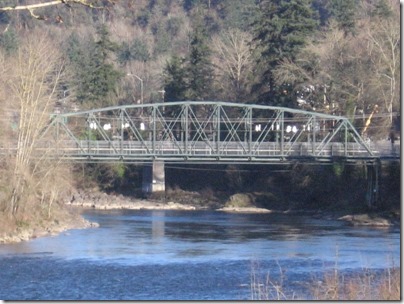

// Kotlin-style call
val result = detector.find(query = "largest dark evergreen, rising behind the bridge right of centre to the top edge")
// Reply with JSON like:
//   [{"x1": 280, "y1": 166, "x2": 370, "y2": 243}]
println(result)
[{"x1": 253, "y1": 0, "x2": 317, "y2": 106}]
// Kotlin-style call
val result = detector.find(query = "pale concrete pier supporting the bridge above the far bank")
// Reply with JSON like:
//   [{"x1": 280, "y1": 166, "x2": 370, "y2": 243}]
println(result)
[{"x1": 142, "y1": 160, "x2": 166, "y2": 193}]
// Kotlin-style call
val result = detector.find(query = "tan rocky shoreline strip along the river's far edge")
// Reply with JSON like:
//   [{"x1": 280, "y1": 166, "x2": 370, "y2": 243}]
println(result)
[{"x1": 0, "y1": 191, "x2": 400, "y2": 244}]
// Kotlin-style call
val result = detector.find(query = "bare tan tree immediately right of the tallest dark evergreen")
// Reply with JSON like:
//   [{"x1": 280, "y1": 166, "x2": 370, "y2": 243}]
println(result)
[{"x1": 273, "y1": 23, "x2": 352, "y2": 114}]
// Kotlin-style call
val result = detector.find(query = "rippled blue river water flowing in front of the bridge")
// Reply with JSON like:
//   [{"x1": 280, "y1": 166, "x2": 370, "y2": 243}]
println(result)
[{"x1": 0, "y1": 210, "x2": 400, "y2": 300}]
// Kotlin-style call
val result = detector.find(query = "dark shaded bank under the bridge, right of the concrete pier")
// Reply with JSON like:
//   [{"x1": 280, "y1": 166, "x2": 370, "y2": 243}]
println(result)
[{"x1": 166, "y1": 163, "x2": 400, "y2": 214}]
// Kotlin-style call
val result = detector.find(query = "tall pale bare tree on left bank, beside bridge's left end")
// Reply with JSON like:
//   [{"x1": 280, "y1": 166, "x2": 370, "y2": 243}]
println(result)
[{"x1": 0, "y1": 33, "x2": 68, "y2": 216}]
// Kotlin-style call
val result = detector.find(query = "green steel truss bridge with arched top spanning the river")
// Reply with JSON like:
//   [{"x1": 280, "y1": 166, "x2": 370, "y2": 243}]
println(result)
[{"x1": 37, "y1": 101, "x2": 400, "y2": 163}]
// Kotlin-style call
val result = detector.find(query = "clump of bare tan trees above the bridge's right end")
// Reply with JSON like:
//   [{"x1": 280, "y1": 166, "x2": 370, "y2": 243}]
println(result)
[{"x1": 274, "y1": 2, "x2": 400, "y2": 137}]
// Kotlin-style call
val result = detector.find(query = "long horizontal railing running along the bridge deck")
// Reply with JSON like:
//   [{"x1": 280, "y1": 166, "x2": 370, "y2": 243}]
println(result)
[{"x1": 0, "y1": 140, "x2": 400, "y2": 163}]
